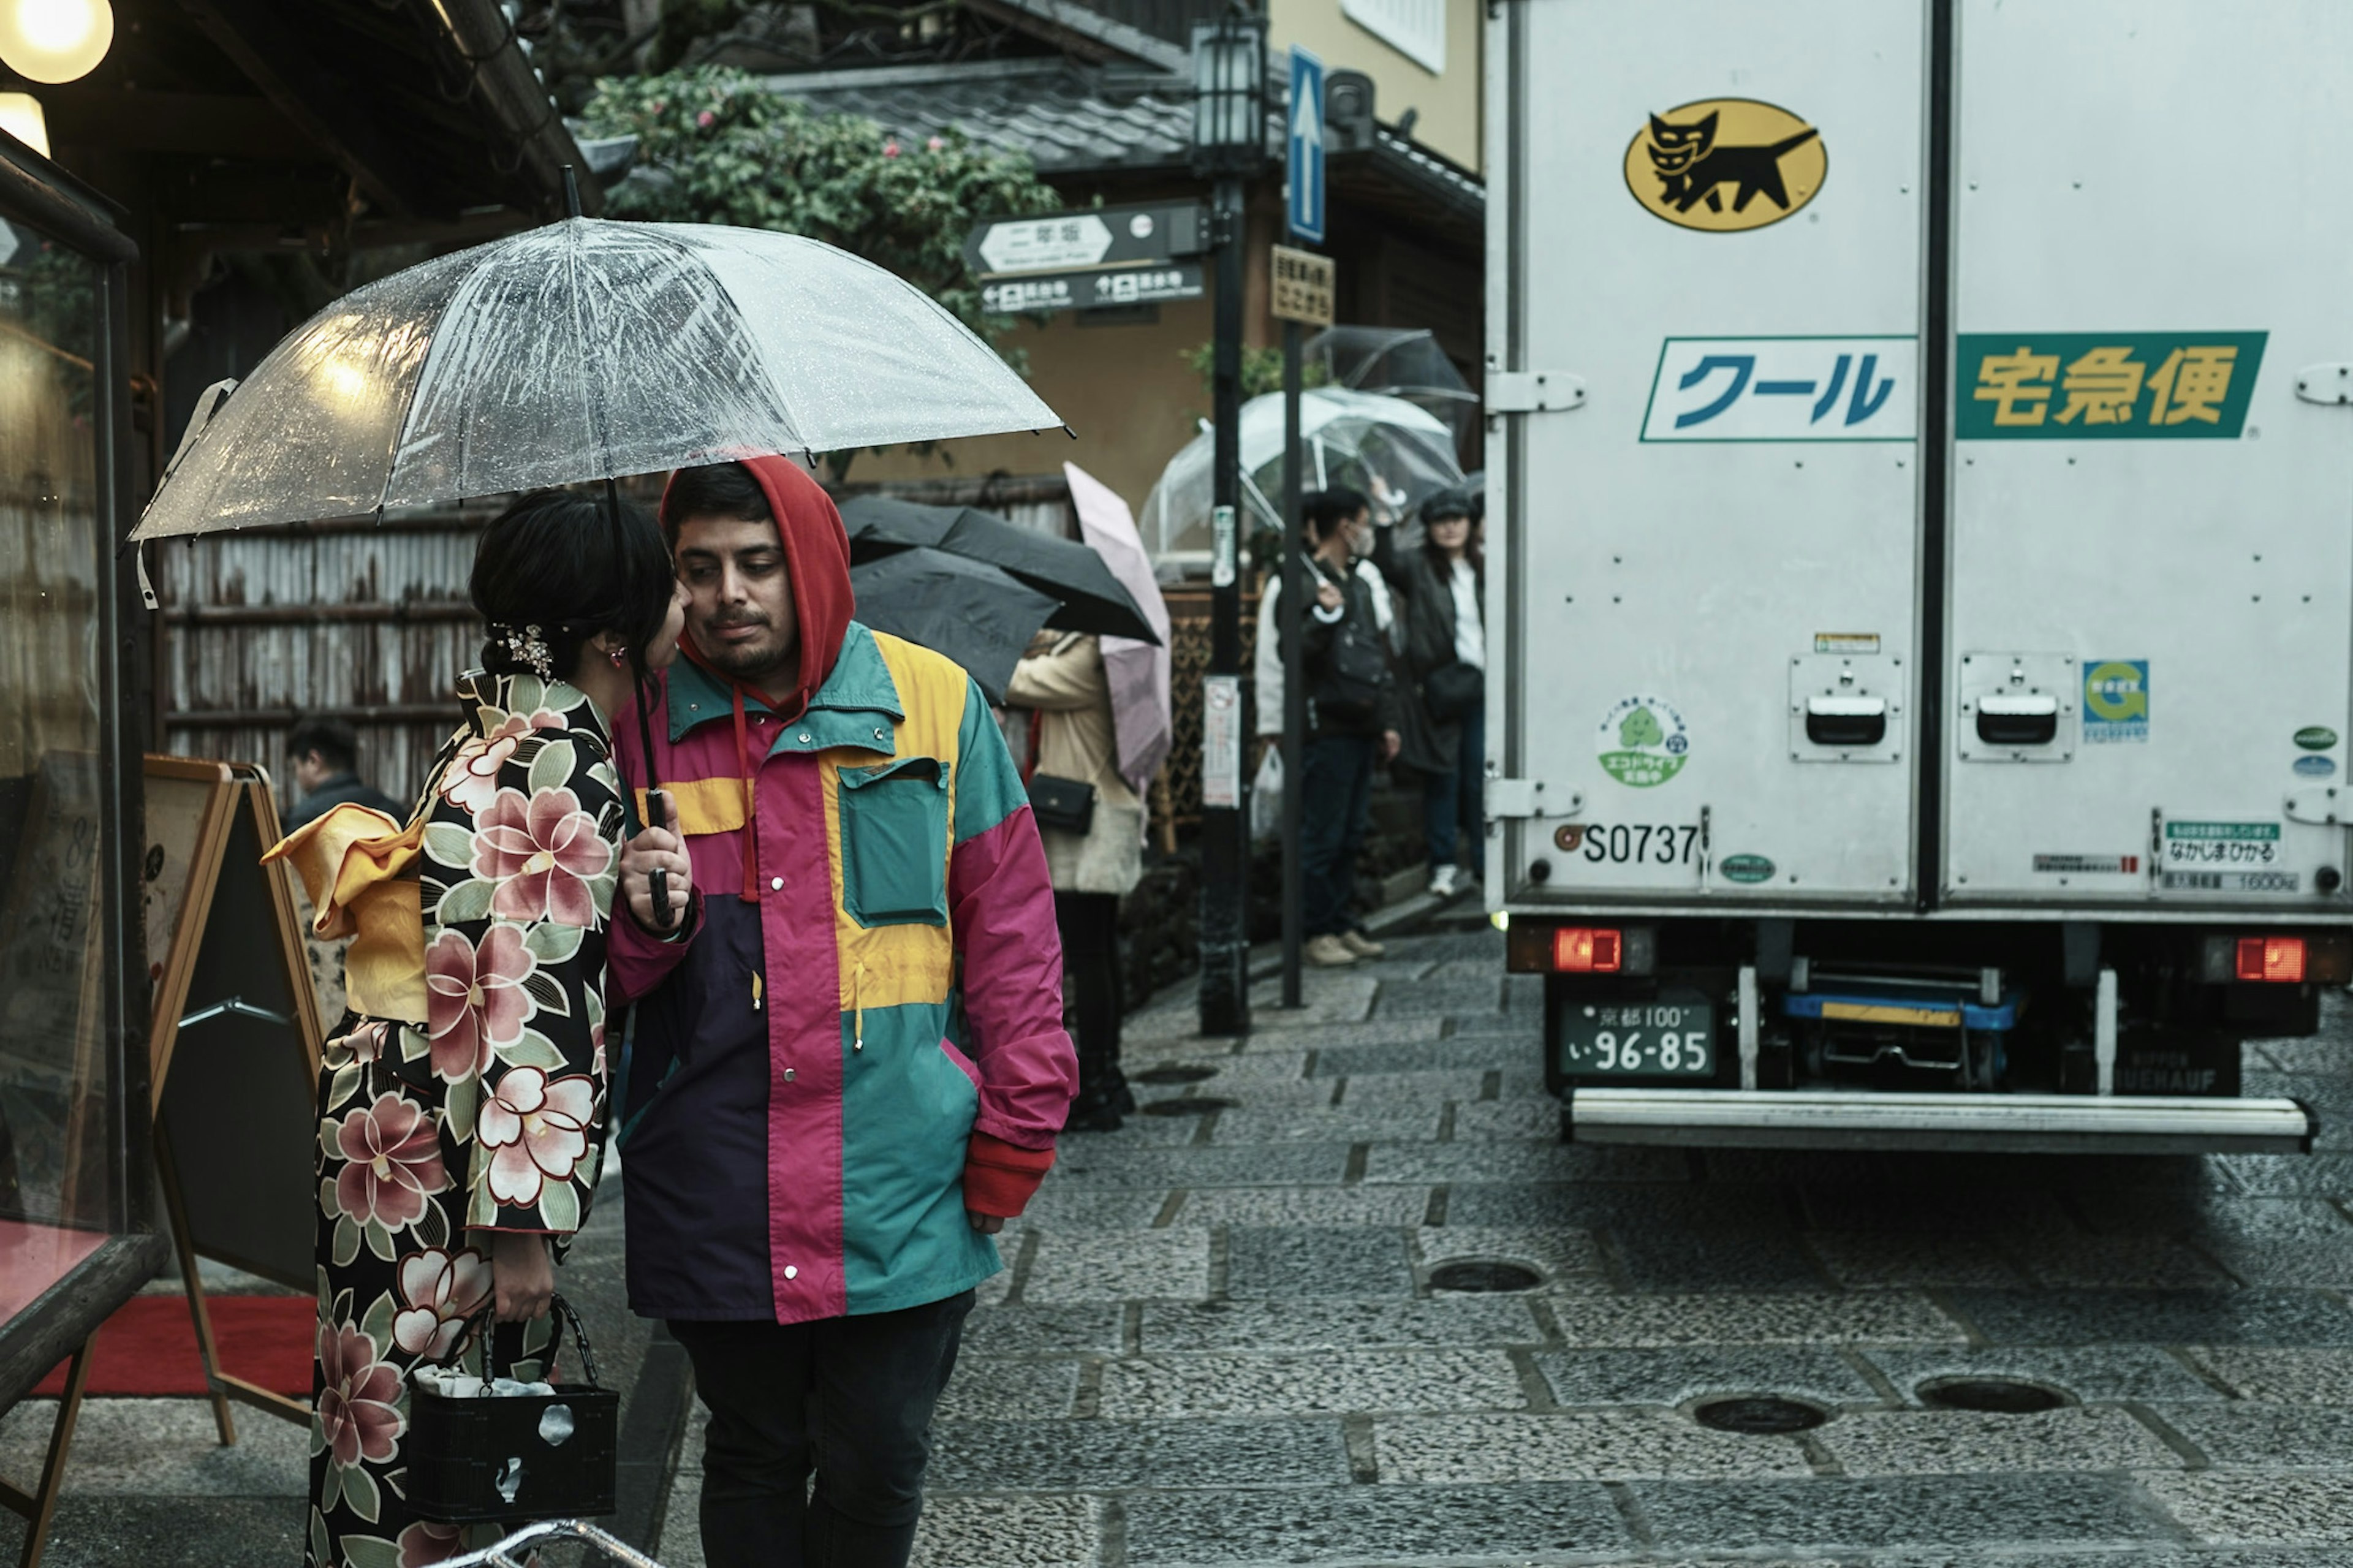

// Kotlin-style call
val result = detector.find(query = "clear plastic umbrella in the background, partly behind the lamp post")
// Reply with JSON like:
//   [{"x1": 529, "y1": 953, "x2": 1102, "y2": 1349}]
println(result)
[{"x1": 1141, "y1": 386, "x2": 1463, "y2": 560}]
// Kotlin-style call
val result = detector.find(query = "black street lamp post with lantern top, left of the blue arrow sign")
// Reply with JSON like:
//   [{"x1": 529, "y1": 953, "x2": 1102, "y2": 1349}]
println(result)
[{"x1": 1193, "y1": 12, "x2": 1266, "y2": 1034}]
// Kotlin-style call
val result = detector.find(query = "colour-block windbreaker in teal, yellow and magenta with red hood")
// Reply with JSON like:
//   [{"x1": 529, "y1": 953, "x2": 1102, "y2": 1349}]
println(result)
[{"x1": 610, "y1": 459, "x2": 1078, "y2": 1323}]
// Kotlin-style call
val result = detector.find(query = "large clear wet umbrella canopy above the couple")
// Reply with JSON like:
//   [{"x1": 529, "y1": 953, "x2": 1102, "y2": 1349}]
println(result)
[{"x1": 132, "y1": 219, "x2": 1061, "y2": 539}]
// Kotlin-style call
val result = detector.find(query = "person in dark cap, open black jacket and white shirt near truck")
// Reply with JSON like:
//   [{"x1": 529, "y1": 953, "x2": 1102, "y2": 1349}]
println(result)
[{"x1": 1389, "y1": 492, "x2": 1487, "y2": 897}]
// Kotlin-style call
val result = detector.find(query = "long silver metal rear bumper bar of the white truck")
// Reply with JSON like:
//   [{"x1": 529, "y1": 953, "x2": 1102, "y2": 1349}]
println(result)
[{"x1": 1563, "y1": 1088, "x2": 2320, "y2": 1154}]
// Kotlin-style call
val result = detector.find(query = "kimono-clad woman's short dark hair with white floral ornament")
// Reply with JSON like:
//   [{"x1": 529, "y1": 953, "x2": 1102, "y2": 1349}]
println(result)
[{"x1": 468, "y1": 490, "x2": 675, "y2": 680}]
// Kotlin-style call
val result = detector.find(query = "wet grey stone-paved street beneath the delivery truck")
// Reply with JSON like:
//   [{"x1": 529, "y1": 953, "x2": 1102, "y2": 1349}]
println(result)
[{"x1": 661, "y1": 930, "x2": 2353, "y2": 1568}]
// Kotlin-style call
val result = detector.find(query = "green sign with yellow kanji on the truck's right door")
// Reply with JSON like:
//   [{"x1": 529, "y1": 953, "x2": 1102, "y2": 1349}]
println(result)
[{"x1": 1953, "y1": 332, "x2": 2268, "y2": 441}]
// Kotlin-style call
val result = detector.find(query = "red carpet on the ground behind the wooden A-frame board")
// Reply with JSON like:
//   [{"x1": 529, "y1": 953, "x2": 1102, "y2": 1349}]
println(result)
[{"x1": 36, "y1": 1295, "x2": 317, "y2": 1398}]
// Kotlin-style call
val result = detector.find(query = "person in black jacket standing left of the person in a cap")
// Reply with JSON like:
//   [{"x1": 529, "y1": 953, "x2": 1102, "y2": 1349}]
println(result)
[{"x1": 1285, "y1": 490, "x2": 1403, "y2": 968}]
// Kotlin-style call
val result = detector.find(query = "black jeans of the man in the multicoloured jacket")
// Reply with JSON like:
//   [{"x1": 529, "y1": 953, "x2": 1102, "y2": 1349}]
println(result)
[{"x1": 670, "y1": 1290, "x2": 972, "y2": 1568}]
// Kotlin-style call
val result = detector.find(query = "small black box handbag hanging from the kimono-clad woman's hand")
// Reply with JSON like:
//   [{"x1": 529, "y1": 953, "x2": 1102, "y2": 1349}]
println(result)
[{"x1": 403, "y1": 1295, "x2": 621, "y2": 1523}]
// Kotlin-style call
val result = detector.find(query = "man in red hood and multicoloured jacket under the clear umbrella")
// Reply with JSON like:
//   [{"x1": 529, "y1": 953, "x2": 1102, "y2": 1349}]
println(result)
[{"x1": 610, "y1": 456, "x2": 1078, "y2": 1568}]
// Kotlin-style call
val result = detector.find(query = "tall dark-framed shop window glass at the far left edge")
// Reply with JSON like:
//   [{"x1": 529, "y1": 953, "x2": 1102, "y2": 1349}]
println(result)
[{"x1": 0, "y1": 219, "x2": 113, "y2": 1321}]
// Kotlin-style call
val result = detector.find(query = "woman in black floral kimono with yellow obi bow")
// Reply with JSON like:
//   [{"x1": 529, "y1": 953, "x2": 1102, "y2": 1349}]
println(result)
[{"x1": 273, "y1": 490, "x2": 692, "y2": 1568}]
